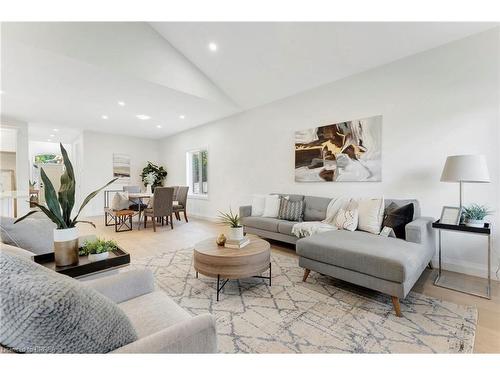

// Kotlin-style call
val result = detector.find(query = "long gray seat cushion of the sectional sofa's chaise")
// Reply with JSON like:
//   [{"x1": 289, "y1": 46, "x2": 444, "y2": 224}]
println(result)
[{"x1": 296, "y1": 230, "x2": 433, "y2": 283}]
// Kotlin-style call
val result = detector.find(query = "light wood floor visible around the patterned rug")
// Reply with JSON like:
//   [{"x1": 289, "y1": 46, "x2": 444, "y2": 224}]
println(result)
[{"x1": 79, "y1": 217, "x2": 500, "y2": 353}]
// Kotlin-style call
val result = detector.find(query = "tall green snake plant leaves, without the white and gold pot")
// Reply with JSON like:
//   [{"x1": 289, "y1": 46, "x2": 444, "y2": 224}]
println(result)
[{"x1": 14, "y1": 143, "x2": 117, "y2": 229}]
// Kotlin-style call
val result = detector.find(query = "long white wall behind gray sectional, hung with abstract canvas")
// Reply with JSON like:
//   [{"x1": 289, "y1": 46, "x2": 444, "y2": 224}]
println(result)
[{"x1": 162, "y1": 30, "x2": 500, "y2": 275}]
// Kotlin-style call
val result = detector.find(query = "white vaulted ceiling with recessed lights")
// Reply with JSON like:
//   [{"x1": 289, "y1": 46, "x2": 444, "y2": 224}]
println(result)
[{"x1": 1, "y1": 22, "x2": 497, "y2": 138}]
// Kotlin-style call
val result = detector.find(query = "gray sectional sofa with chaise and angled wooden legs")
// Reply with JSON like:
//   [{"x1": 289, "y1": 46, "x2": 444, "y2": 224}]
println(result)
[{"x1": 240, "y1": 195, "x2": 435, "y2": 316}]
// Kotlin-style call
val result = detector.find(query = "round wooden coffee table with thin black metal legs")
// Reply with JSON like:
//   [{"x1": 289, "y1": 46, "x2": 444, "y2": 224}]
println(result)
[{"x1": 194, "y1": 237, "x2": 271, "y2": 301}]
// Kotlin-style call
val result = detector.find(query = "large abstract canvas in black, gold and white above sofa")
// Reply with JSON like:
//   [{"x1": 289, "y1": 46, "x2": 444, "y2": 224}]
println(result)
[{"x1": 295, "y1": 116, "x2": 382, "y2": 182}]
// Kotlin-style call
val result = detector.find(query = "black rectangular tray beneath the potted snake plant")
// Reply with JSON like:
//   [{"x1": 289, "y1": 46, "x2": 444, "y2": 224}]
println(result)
[{"x1": 33, "y1": 247, "x2": 130, "y2": 277}]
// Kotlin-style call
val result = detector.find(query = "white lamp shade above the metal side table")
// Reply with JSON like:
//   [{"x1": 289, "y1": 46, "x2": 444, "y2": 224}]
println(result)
[{"x1": 441, "y1": 155, "x2": 490, "y2": 182}]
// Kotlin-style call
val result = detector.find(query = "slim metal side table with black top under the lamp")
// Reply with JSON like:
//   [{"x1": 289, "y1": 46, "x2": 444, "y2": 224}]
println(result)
[{"x1": 432, "y1": 220, "x2": 491, "y2": 299}]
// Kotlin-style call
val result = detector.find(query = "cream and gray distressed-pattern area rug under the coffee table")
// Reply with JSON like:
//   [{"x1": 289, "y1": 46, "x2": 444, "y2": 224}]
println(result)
[{"x1": 132, "y1": 249, "x2": 477, "y2": 353}]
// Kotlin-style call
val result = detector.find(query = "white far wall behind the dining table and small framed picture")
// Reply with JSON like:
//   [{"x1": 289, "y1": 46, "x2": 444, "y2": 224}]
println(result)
[{"x1": 79, "y1": 131, "x2": 160, "y2": 216}]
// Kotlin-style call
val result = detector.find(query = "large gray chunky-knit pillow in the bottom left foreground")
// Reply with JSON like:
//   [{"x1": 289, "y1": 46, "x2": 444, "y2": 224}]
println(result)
[{"x1": 0, "y1": 252, "x2": 137, "y2": 353}]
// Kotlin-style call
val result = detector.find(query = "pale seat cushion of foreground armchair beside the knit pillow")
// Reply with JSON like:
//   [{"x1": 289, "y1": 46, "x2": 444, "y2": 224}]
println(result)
[{"x1": 118, "y1": 291, "x2": 191, "y2": 338}]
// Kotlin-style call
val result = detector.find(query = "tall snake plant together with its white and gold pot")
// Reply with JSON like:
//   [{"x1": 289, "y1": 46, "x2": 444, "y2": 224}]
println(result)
[{"x1": 14, "y1": 143, "x2": 117, "y2": 266}]
